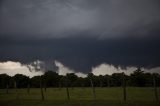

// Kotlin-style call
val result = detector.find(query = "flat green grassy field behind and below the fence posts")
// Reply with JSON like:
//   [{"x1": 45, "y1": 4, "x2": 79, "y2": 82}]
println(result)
[{"x1": 0, "y1": 87, "x2": 160, "y2": 106}]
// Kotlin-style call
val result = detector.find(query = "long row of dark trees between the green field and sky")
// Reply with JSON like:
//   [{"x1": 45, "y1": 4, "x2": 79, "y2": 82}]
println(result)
[{"x1": 0, "y1": 68, "x2": 160, "y2": 89}]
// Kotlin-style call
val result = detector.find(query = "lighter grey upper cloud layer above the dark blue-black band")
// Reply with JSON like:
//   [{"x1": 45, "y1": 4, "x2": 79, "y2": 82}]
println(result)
[{"x1": 0, "y1": 0, "x2": 160, "y2": 38}]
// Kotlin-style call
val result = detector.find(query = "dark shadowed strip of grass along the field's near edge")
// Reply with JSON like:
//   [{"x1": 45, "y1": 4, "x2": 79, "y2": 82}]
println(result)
[{"x1": 0, "y1": 100, "x2": 160, "y2": 106}]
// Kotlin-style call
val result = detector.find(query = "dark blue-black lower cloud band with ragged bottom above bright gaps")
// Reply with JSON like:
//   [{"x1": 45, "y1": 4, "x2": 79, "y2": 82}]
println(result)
[{"x1": 0, "y1": 37, "x2": 160, "y2": 72}]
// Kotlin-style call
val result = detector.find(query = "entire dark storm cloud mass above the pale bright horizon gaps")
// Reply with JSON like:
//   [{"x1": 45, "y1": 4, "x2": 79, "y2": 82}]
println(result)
[{"x1": 0, "y1": 0, "x2": 160, "y2": 73}]
